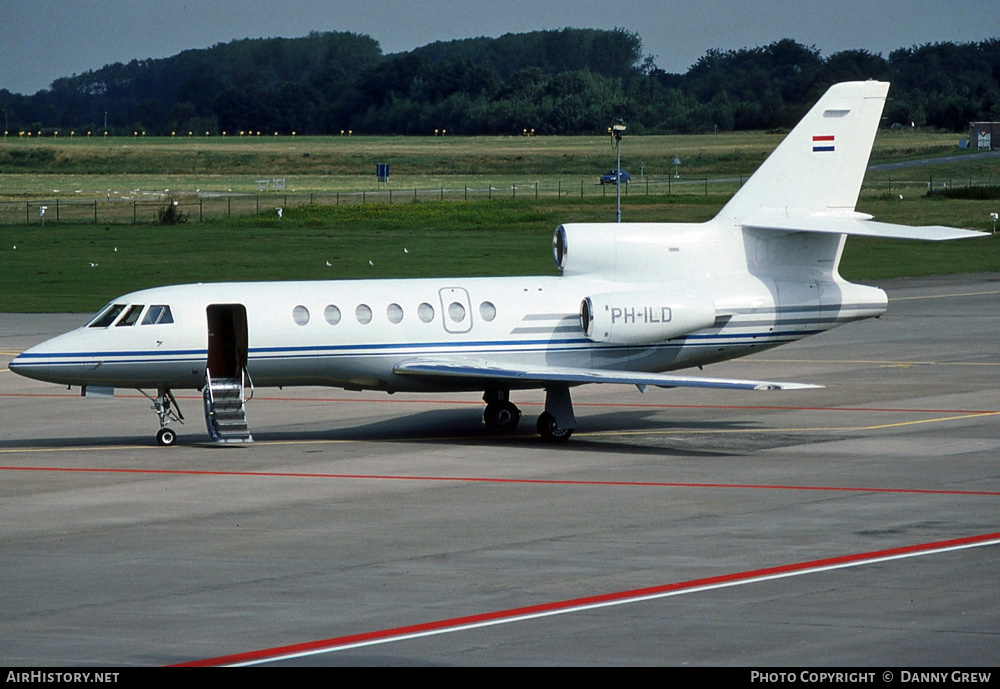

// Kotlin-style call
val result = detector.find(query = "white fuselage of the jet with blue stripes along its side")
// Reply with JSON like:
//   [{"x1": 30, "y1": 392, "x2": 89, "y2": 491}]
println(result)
[{"x1": 11, "y1": 266, "x2": 885, "y2": 392}]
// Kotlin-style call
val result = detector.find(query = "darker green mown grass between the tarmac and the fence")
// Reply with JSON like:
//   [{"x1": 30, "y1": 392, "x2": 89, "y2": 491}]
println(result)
[{"x1": 0, "y1": 196, "x2": 1000, "y2": 312}]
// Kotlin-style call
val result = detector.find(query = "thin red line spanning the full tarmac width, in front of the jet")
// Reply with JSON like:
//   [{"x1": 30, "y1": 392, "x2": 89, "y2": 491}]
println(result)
[{"x1": 0, "y1": 466, "x2": 1000, "y2": 496}]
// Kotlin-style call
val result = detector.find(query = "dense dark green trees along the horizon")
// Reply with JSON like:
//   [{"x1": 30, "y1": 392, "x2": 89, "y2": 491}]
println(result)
[{"x1": 0, "y1": 29, "x2": 1000, "y2": 134}]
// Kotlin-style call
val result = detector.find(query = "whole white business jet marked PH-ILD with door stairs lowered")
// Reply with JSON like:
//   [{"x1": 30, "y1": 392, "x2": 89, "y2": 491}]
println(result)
[{"x1": 10, "y1": 81, "x2": 982, "y2": 445}]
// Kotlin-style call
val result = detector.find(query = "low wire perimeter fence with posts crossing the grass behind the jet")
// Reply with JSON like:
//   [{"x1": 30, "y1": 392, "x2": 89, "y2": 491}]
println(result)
[{"x1": 0, "y1": 176, "x2": 994, "y2": 225}]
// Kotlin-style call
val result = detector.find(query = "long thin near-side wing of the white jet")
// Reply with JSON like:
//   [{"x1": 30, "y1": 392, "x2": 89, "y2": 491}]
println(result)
[{"x1": 393, "y1": 358, "x2": 823, "y2": 390}]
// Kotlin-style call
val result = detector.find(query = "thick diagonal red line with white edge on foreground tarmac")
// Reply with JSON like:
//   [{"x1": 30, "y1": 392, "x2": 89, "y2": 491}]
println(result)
[{"x1": 175, "y1": 532, "x2": 1000, "y2": 667}]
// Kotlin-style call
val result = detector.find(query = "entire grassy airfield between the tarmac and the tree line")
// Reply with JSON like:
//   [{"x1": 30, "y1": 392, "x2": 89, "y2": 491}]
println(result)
[{"x1": 0, "y1": 131, "x2": 1000, "y2": 312}]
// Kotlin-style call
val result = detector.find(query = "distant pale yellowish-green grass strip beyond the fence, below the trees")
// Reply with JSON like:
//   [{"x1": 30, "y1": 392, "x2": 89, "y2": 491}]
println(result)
[{"x1": 0, "y1": 131, "x2": 988, "y2": 200}]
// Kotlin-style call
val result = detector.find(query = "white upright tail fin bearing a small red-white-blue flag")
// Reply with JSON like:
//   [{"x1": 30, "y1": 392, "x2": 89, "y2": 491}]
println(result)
[{"x1": 718, "y1": 81, "x2": 889, "y2": 223}]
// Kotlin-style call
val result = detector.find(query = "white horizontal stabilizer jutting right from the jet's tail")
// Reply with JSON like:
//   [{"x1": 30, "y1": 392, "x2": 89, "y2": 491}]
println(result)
[{"x1": 743, "y1": 213, "x2": 989, "y2": 241}]
